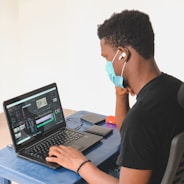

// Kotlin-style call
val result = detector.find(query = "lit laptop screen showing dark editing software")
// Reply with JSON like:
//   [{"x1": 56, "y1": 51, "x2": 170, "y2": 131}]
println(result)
[{"x1": 4, "y1": 83, "x2": 66, "y2": 148}]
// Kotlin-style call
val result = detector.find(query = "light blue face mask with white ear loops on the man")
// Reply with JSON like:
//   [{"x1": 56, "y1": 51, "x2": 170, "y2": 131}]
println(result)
[{"x1": 106, "y1": 50, "x2": 126, "y2": 88}]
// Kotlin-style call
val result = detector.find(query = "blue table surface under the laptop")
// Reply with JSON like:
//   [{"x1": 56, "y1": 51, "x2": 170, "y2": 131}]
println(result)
[{"x1": 0, "y1": 111, "x2": 120, "y2": 184}]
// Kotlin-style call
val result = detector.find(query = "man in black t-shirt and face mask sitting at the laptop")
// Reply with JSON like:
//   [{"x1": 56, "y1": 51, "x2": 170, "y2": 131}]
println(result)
[{"x1": 46, "y1": 10, "x2": 184, "y2": 184}]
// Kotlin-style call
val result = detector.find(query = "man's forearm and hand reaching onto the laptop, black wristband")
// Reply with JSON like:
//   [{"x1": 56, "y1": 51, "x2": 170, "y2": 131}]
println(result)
[{"x1": 46, "y1": 145, "x2": 119, "y2": 184}]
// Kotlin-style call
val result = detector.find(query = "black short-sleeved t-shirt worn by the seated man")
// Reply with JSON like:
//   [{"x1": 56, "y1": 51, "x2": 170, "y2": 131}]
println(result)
[{"x1": 117, "y1": 73, "x2": 184, "y2": 184}]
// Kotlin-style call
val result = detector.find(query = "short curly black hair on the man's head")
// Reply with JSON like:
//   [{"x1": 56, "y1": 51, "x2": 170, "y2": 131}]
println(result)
[{"x1": 97, "y1": 10, "x2": 154, "y2": 59}]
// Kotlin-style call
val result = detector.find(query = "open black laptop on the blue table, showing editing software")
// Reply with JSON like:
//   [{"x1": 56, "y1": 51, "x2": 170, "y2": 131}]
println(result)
[{"x1": 3, "y1": 83, "x2": 103, "y2": 169}]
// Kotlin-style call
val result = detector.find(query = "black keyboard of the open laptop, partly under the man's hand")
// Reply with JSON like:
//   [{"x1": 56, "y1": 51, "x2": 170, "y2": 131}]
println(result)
[{"x1": 26, "y1": 129, "x2": 83, "y2": 159}]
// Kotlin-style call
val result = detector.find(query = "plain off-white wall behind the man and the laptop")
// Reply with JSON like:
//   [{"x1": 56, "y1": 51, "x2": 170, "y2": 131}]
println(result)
[{"x1": 0, "y1": 0, "x2": 184, "y2": 115}]
